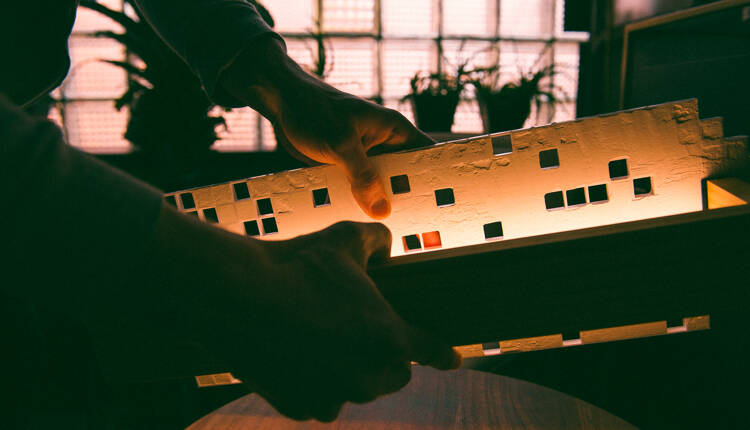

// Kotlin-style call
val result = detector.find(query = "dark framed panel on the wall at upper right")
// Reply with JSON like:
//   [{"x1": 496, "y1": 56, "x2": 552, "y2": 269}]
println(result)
[{"x1": 623, "y1": 2, "x2": 750, "y2": 136}]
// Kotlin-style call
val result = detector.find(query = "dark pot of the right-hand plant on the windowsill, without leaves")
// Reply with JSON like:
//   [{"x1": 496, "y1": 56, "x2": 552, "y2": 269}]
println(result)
[{"x1": 477, "y1": 92, "x2": 531, "y2": 133}]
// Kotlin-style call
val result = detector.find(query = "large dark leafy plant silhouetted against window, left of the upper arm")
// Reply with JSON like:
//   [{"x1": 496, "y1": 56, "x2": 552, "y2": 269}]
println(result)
[{"x1": 80, "y1": 0, "x2": 273, "y2": 183}]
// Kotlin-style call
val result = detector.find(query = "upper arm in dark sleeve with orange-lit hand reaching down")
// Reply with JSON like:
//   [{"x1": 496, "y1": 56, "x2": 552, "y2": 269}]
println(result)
[{"x1": 138, "y1": 0, "x2": 434, "y2": 219}]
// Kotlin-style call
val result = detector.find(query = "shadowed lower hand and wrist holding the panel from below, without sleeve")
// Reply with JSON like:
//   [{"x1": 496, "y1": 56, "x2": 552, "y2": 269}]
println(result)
[{"x1": 159, "y1": 207, "x2": 461, "y2": 421}]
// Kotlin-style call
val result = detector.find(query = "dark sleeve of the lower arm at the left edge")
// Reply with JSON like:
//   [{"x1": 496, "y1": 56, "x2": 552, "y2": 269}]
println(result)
[{"x1": 0, "y1": 95, "x2": 162, "y2": 366}]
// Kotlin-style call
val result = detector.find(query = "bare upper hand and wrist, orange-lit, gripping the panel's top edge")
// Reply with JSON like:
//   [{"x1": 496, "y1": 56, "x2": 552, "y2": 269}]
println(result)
[{"x1": 222, "y1": 37, "x2": 435, "y2": 219}]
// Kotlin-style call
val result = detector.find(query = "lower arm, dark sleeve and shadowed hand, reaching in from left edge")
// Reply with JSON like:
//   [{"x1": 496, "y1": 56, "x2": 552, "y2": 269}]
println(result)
[{"x1": 0, "y1": 94, "x2": 459, "y2": 420}]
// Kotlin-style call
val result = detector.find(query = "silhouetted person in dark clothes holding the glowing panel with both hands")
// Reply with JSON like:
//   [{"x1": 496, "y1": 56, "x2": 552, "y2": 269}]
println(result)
[{"x1": 0, "y1": 0, "x2": 460, "y2": 428}]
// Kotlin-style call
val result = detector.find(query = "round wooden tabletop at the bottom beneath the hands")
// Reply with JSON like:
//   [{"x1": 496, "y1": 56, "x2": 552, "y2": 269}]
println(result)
[{"x1": 188, "y1": 366, "x2": 635, "y2": 430}]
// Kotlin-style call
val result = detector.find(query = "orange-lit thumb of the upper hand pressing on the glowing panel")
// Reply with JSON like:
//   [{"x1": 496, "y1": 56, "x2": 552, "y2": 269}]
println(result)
[{"x1": 336, "y1": 143, "x2": 391, "y2": 219}]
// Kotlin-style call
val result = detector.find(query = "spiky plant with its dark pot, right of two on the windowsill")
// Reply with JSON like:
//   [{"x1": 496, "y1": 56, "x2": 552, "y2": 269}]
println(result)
[{"x1": 470, "y1": 45, "x2": 562, "y2": 133}]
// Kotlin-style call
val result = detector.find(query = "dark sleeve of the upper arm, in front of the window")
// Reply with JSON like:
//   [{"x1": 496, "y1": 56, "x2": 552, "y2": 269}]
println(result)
[{"x1": 136, "y1": 0, "x2": 282, "y2": 107}]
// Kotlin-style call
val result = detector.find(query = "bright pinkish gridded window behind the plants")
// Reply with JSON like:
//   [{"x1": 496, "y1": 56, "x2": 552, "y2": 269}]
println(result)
[{"x1": 57, "y1": 0, "x2": 587, "y2": 153}]
